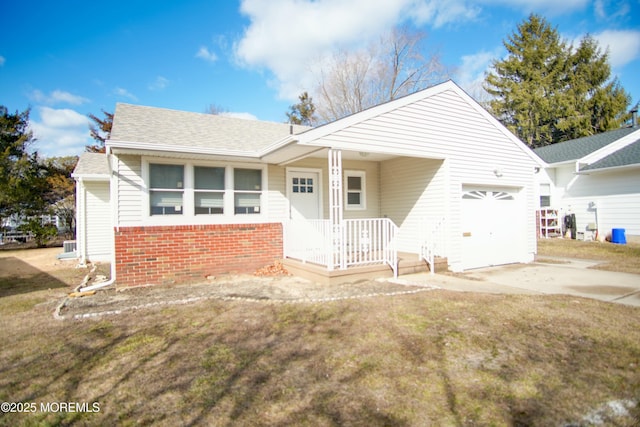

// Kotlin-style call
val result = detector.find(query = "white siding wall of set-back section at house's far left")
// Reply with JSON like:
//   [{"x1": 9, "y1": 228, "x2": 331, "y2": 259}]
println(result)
[{"x1": 83, "y1": 181, "x2": 113, "y2": 261}]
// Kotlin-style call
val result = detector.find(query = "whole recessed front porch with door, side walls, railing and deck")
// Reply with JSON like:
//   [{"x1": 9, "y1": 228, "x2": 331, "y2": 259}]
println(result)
[{"x1": 283, "y1": 149, "x2": 447, "y2": 283}]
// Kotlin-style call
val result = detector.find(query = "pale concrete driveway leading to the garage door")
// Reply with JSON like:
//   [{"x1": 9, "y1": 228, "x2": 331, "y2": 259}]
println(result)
[{"x1": 399, "y1": 257, "x2": 640, "y2": 307}]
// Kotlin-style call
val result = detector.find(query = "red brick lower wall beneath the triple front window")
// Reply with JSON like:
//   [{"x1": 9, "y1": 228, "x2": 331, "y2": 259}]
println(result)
[{"x1": 115, "y1": 223, "x2": 282, "y2": 286}]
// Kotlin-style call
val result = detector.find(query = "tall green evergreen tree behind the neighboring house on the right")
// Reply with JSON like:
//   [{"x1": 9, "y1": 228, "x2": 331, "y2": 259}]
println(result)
[{"x1": 485, "y1": 14, "x2": 630, "y2": 148}]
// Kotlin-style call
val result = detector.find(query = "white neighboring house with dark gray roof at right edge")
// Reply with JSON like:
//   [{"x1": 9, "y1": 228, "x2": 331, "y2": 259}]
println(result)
[{"x1": 534, "y1": 121, "x2": 640, "y2": 239}]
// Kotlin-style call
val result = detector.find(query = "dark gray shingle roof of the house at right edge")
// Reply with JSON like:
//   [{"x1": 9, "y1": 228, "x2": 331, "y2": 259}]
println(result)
[{"x1": 533, "y1": 127, "x2": 640, "y2": 164}]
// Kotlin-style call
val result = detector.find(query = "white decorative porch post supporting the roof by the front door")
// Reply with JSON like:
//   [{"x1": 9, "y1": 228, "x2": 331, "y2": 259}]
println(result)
[{"x1": 328, "y1": 148, "x2": 347, "y2": 270}]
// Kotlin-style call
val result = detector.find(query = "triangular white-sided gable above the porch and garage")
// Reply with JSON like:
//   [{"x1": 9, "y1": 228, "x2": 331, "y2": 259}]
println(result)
[{"x1": 298, "y1": 80, "x2": 546, "y2": 166}]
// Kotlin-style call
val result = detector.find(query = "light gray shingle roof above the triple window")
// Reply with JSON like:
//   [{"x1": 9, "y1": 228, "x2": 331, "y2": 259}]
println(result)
[{"x1": 110, "y1": 103, "x2": 310, "y2": 152}]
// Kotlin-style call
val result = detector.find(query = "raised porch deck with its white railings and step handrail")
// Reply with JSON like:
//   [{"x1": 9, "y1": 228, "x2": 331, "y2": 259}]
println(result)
[{"x1": 283, "y1": 218, "x2": 447, "y2": 284}]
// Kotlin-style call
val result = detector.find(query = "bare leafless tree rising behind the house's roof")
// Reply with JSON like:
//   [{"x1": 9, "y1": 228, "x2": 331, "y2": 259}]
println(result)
[{"x1": 317, "y1": 27, "x2": 448, "y2": 122}]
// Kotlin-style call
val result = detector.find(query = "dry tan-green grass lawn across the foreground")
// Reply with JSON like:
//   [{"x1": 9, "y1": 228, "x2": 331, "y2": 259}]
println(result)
[{"x1": 0, "y1": 242, "x2": 640, "y2": 426}]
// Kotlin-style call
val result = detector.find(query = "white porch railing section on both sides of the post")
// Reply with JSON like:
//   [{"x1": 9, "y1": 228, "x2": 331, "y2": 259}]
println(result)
[{"x1": 283, "y1": 218, "x2": 398, "y2": 276}]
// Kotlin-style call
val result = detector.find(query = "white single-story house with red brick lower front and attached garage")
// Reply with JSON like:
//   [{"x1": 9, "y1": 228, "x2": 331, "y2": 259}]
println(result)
[{"x1": 74, "y1": 81, "x2": 544, "y2": 285}]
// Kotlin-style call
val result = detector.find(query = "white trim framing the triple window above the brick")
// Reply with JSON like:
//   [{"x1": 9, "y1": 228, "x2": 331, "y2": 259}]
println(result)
[{"x1": 140, "y1": 156, "x2": 269, "y2": 225}]
